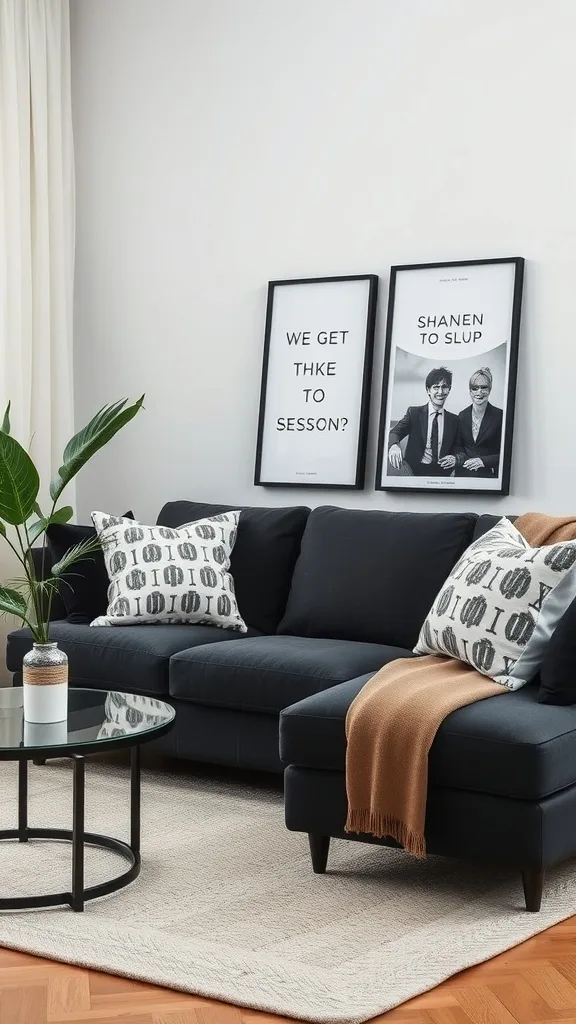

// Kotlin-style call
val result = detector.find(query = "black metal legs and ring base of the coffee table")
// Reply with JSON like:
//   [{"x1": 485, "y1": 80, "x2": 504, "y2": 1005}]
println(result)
[{"x1": 0, "y1": 746, "x2": 140, "y2": 910}]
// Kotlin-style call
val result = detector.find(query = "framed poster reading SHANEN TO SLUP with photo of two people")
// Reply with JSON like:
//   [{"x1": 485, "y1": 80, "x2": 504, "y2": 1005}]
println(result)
[{"x1": 376, "y1": 257, "x2": 524, "y2": 495}]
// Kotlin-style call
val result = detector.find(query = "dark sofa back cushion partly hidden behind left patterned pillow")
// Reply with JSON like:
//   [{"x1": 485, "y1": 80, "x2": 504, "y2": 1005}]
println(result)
[{"x1": 158, "y1": 501, "x2": 310, "y2": 633}]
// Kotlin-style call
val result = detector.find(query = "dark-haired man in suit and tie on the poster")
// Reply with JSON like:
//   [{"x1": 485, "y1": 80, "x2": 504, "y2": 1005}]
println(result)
[{"x1": 388, "y1": 367, "x2": 458, "y2": 476}]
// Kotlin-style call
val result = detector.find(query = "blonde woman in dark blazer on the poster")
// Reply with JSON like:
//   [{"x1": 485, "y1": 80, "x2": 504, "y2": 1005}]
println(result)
[{"x1": 456, "y1": 367, "x2": 502, "y2": 479}]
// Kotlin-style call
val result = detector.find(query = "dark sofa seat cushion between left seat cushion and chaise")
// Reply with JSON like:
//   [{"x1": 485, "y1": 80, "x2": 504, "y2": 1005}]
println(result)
[{"x1": 170, "y1": 637, "x2": 411, "y2": 715}]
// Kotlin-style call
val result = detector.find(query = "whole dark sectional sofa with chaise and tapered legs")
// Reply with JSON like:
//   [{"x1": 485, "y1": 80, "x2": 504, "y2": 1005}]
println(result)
[{"x1": 7, "y1": 501, "x2": 576, "y2": 909}]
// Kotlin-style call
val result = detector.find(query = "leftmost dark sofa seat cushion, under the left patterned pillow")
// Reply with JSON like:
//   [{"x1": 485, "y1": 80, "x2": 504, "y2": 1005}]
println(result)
[{"x1": 6, "y1": 622, "x2": 256, "y2": 695}]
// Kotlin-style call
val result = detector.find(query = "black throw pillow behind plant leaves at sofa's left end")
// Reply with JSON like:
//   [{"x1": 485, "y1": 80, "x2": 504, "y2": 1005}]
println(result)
[{"x1": 46, "y1": 512, "x2": 134, "y2": 626}]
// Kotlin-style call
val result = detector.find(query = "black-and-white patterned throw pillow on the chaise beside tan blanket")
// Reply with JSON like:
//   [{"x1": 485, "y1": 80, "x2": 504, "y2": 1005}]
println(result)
[{"x1": 414, "y1": 518, "x2": 576, "y2": 690}]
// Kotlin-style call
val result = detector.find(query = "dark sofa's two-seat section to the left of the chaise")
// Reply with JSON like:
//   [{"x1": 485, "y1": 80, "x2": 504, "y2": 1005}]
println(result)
[{"x1": 7, "y1": 502, "x2": 478, "y2": 772}]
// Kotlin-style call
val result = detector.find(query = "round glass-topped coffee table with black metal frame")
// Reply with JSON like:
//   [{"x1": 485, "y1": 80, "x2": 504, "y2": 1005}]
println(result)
[{"x1": 0, "y1": 686, "x2": 175, "y2": 910}]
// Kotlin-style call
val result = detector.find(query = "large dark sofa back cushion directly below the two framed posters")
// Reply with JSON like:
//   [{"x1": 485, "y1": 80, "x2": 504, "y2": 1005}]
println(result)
[{"x1": 279, "y1": 506, "x2": 477, "y2": 647}]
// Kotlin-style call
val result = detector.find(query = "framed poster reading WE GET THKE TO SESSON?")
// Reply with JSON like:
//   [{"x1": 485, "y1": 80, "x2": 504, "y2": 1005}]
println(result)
[{"x1": 254, "y1": 274, "x2": 378, "y2": 488}]
